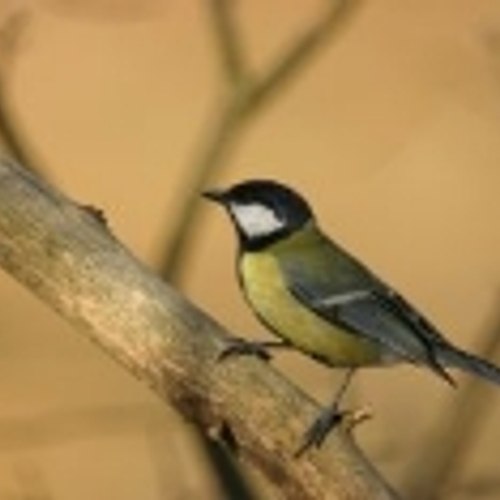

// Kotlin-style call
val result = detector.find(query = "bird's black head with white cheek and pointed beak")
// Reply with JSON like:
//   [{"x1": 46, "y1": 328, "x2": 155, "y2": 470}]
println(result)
[{"x1": 203, "y1": 180, "x2": 314, "y2": 250}]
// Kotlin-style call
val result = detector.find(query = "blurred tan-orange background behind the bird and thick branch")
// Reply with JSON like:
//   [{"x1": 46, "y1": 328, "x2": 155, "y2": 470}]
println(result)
[{"x1": 0, "y1": 0, "x2": 500, "y2": 500}]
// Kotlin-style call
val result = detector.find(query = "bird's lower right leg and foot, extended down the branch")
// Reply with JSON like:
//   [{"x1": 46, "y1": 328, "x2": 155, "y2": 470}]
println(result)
[{"x1": 294, "y1": 368, "x2": 356, "y2": 458}]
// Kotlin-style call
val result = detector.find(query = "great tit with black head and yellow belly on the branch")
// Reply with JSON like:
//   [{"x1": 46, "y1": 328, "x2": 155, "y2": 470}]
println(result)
[{"x1": 204, "y1": 180, "x2": 500, "y2": 453}]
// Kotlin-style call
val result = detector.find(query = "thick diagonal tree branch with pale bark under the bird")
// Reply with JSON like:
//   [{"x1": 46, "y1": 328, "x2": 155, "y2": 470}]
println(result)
[{"x1": 0, "y1": 159, "x2": 395, "y2": 500}]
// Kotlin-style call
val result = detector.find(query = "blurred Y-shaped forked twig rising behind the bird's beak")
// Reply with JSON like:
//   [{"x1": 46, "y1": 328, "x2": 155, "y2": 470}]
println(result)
[{"x1": 160, "y1": 0, "x2": 358, "y2": 283}]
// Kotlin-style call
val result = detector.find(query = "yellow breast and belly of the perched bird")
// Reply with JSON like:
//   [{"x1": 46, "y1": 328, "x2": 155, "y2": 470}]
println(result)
[{"x1": 240, "y1": 252, "x2": 381, "y2": 366}]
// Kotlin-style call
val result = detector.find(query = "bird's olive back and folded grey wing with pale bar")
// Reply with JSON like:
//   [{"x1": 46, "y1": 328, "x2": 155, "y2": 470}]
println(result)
[{"x1": 282, "y1": 236, "x2": 451, "y2": 382}]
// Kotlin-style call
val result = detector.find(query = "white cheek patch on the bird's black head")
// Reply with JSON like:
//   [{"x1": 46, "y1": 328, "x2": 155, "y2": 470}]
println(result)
[{"x1": 230, "y1": 203, "x2": 285, "y2": 238}]
